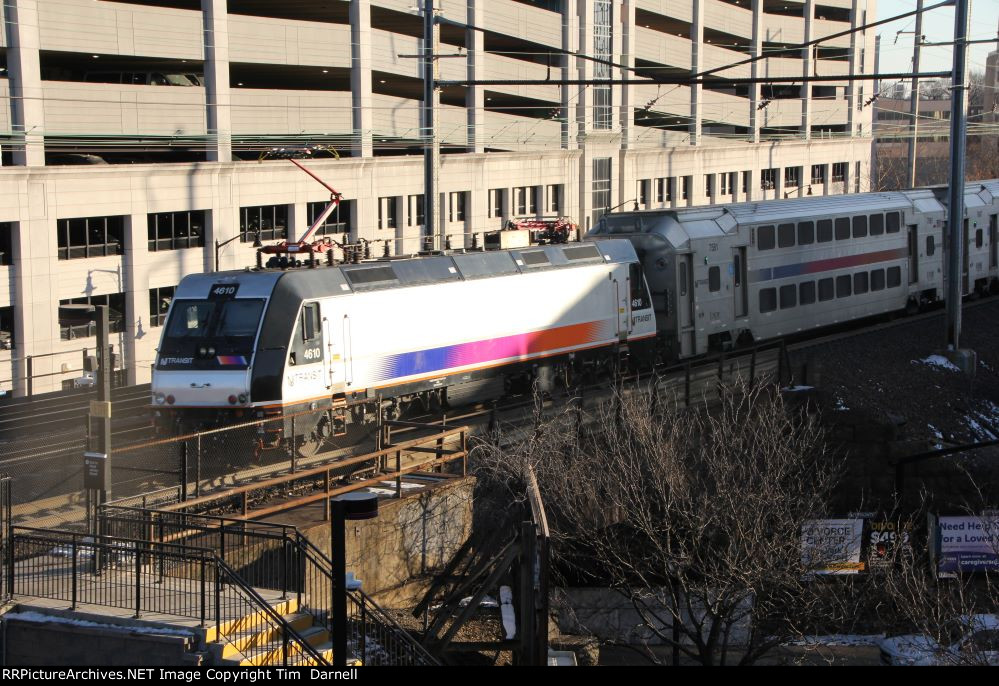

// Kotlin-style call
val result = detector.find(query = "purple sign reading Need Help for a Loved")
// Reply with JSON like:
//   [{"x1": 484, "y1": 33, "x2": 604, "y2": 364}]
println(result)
[{"x1": 937, "y1": 514, "x2": 999, "y2": 576}]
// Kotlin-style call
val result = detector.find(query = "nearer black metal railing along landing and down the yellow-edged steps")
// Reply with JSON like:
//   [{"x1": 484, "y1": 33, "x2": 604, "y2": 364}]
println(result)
[{"x1": 5, "y1": 526, "x2": 329, "y2": 665}]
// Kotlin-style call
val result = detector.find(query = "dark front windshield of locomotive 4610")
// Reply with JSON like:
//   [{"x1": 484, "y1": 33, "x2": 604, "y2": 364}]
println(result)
[{"x1": 158, "y1": 298, "x2": 264, "y2": 369}]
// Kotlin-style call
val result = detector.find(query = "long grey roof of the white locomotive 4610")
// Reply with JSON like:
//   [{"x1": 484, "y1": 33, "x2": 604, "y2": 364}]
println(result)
[{"x1": 175, "y1": 240, "x2": 637, "y2": 299}]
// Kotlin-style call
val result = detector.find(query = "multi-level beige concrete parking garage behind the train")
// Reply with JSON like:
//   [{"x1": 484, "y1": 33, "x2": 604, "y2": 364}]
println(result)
[{"x1": 0, "y1": 0, "x2": 875, "y2": 395}]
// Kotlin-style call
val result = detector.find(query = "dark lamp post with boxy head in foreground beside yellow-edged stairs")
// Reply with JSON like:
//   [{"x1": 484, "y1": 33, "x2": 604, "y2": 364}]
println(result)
[{"x1": 330, "y1": 492, "x2": 378, "y2": 667}]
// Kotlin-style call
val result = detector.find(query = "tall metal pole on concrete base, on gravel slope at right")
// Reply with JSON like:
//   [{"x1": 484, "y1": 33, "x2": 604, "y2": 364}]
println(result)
[{"x1": 946, "y1": 0, "x2": 977, "y2": 375}]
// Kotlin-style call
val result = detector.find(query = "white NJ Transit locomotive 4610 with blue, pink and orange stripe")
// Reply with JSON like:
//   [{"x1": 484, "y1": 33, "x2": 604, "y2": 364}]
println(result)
[{"x1": 152, "y1": 240, "x2": 655, "y2": 440}]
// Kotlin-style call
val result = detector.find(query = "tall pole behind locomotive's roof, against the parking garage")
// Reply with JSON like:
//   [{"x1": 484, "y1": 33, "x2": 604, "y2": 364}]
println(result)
[{"x1": 423, "y1": 0, "x2": 445, "y2": 250}]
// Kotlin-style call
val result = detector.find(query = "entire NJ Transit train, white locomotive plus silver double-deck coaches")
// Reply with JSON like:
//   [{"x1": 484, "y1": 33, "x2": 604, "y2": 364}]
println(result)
[{"x1": 153, "y1": 181, "x2": 999, "y2": 441}]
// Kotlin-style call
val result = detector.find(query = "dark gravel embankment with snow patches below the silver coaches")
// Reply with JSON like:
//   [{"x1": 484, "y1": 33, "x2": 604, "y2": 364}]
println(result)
[{"x1": 791, "y1": 302, "x2": 999, "y2": 511}]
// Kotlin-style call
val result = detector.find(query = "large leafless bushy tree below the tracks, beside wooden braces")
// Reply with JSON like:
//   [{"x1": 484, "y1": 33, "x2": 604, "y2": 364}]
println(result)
[{"x1": 477, "y1": 385, "x2": 838, "y2": 665}]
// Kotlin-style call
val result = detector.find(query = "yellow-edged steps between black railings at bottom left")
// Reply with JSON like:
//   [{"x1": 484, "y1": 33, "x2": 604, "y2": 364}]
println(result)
[{"x1": 206, "y1": 599, "x2": 352, "y2": 667}]
